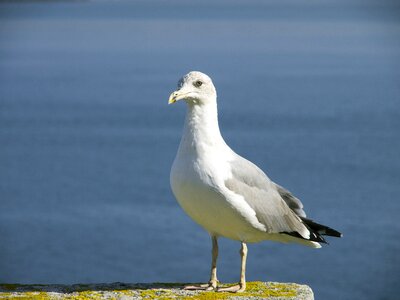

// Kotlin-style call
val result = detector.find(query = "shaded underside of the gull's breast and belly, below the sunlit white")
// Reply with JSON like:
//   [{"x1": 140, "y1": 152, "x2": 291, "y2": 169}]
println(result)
[{"x1": 171, "y1": 154, "x2": 265, "y2": 242}]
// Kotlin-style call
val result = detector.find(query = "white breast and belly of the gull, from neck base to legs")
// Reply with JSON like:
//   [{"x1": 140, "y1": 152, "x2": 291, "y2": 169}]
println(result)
[{"x1": 170, "y1": 149, "x2": 265, "y2": 241}]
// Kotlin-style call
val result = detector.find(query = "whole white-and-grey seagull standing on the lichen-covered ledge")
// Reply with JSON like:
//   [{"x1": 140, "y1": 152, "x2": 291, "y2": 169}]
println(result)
[{"x1": 168, "y1": 71, "x2": 342, "y2": 292}]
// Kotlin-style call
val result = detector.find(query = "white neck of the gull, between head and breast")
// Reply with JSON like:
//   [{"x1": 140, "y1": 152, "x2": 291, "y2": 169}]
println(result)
[{"x1": 179, "y1": 101, "x2": 227, "y2": 155}]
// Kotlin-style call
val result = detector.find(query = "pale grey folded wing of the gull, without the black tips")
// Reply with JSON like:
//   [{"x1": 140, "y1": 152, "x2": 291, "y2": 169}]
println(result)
[{"x1": 225, "y1": 155, "x2": 310, "y2": 238}]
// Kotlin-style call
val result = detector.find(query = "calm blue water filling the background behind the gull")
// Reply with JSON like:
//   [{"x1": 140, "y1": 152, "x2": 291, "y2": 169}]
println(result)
[{"x1": 0, "y1": 0, "x2": 400, "y2": 300}]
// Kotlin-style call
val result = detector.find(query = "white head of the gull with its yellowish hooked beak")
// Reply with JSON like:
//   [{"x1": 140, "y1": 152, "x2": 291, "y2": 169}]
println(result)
[{"x1": 168, "y1": 71, "x2": 217, "y2": 105}]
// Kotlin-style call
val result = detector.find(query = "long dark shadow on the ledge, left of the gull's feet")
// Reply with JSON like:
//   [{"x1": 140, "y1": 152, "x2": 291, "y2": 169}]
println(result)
[{"x1": 0, "y1": 282, "x2": 184, "y2": 294}]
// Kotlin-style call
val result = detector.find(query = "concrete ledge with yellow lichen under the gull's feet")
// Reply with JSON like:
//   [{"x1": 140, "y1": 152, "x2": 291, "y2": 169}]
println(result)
[{"x1": 0, "y1": 281, "x2": 314, "y2": 300}]
